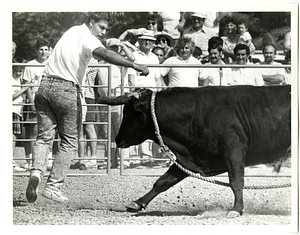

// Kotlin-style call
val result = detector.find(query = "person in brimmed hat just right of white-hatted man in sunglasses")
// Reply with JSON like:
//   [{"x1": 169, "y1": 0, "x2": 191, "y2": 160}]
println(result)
[{"x1": 154, "y1": 32, "x2": 176, "y2": 60}]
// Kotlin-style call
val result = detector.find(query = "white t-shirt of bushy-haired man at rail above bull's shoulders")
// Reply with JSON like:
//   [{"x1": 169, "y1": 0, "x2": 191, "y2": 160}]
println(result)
[{"x1": 160, "y1": 56, "x2": 207, "y2": 87}]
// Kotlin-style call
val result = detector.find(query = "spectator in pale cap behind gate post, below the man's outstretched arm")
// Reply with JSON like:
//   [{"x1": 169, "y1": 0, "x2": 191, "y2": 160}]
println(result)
[{"x1": 97, "y1": 38, "x2": 135, "y2": 168}]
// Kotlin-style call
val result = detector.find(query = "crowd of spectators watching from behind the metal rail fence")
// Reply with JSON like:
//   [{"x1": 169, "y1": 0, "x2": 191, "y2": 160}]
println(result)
[{"x1": 13, "y1": 12, "x2": 291, "y2": 171}]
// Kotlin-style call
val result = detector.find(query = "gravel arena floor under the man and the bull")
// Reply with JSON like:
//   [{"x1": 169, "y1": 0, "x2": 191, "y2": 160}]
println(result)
[{"x1": 13, "y1": 159, "x2": 293, "y2": 232}]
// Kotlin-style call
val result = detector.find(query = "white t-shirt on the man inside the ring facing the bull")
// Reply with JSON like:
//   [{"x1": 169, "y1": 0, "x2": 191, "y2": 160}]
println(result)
[{"x1": 43, "y1": 24, "x2": 104, "y2": 86}]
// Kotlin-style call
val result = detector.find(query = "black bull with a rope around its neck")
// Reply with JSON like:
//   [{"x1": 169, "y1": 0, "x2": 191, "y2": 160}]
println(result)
[{"x1": 98, "y1": 85, "x2": 291, "y2": 216}]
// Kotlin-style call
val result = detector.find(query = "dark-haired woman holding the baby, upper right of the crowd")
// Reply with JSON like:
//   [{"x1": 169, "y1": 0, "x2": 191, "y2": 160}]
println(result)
[{"x1": 221, "y1": 18, "x2": 239, "y2": 64}]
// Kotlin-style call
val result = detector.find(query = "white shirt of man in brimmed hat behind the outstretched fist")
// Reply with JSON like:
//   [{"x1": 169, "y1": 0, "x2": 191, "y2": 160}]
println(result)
[{"x1": 128, "y1": 51, "x2": 160, "y2": 87}]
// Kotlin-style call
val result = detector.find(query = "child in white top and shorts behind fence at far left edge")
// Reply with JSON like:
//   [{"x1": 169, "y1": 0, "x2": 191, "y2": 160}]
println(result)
[{"x1": 12, "y1": 55, "x2": 28, "y2": 171}]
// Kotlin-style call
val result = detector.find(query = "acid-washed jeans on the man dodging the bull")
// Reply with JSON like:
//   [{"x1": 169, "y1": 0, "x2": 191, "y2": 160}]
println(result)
[{"x1": 32, "y1": 77, "x2": 81, "y2": 187}]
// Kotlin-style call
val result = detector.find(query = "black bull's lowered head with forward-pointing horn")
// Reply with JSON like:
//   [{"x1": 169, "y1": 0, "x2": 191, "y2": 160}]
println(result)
[{"x1": 100, "y1": 89, "x2": 155, "y2": 148}]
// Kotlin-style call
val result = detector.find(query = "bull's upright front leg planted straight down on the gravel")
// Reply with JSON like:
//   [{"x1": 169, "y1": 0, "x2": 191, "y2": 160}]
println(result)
[{"x1": 225, "y1": 138, "x2": 245, "y2": 217}]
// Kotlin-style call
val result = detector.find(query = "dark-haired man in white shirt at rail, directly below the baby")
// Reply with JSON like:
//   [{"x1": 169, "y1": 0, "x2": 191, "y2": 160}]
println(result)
[{"x1": 229, "y1": 44, "x2": 264, "y2": 86}]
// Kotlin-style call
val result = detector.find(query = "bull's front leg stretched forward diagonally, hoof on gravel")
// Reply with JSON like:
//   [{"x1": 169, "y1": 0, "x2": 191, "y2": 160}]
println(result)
[{"x1": 126, "y1": 165, "x2": 188, "y2": 212}]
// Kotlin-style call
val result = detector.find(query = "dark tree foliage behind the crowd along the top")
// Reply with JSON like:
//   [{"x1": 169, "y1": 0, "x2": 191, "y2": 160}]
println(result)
[{"x1": 12, "y1": 12, "x2": 290, "y2": 60}]
